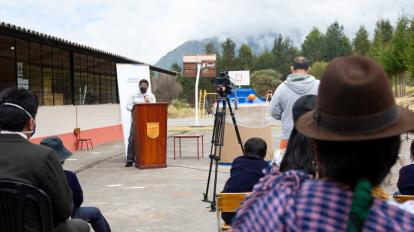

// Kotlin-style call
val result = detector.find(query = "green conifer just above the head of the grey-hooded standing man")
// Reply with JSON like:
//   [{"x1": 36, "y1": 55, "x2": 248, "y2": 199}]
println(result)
[{"x1": 302, "y1": 27, "x2": 324, "y2": 63}]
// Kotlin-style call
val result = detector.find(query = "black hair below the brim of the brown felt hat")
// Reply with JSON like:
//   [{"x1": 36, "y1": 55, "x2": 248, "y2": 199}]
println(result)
[{"x1": 316, "y1": 136, "x2": 401, "y2": 188}]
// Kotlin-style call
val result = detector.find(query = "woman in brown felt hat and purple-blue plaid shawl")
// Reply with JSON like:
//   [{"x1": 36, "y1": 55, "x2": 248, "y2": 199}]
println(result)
[{"x1": 232, "y1": 56, "x2": 414, "y2": 231}]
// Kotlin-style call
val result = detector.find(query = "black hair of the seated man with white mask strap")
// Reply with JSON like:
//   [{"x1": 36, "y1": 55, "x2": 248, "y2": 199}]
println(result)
[{"x1": 0, "y1": 87, "x2": 39, "y2": 131}]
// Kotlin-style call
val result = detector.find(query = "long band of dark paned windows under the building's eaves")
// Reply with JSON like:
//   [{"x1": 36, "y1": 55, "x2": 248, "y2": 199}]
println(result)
[{"x1": 9, "y1": 35, "x2": 118, "y2": 105}]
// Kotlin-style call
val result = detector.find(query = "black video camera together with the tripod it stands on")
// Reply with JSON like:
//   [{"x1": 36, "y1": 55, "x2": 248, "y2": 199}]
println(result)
[{"x1": 203, "y1": 71, "x2": 244, "y2": 212}]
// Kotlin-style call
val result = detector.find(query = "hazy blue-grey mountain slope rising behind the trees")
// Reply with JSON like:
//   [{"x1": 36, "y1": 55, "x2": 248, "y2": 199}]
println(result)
[{"x1": 155, "y1": 33, "x2": 277, "y2": 69}]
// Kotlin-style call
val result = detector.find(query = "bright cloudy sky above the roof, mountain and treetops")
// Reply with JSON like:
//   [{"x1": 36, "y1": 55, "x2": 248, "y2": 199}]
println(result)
[{"x1": 0, "y1": 0, "x2": 414, "y2": 64}]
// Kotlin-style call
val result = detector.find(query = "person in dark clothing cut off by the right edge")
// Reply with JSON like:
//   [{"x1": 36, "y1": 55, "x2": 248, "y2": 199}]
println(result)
[{"x1": 397, "y1": 141, "x2": 414, "y2": 195}]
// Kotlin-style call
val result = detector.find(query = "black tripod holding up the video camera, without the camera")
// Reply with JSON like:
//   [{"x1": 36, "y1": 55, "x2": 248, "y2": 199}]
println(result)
[{"x1": 202, "y1": 94, "x2": 244, "y2": 212}]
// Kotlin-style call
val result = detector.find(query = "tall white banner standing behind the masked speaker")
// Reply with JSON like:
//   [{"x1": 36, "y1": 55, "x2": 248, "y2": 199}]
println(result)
[{"x1": 116, "y1": 64, "x2": 151, "y2": 156}]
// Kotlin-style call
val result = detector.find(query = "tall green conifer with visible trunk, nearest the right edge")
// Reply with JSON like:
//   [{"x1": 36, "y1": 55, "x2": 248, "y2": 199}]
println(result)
[{"x1": 381, "y1": 17, "x2": 408, "y2": 97}]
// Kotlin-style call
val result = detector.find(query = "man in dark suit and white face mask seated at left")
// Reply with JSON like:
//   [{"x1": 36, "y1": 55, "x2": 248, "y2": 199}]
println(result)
[{"x1": 0, "y1": 88, "x2": 89, "y2": 232}]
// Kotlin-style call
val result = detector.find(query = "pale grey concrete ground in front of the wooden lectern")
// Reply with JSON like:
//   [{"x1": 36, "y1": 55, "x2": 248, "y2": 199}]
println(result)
[{"x1": 64, "y1": 119, "x2": 414, "y2": 232}]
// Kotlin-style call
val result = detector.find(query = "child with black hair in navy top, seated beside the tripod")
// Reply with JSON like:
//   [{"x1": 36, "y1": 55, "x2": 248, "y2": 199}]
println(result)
[{"x1": 221, "y1": 138, "x2": 270, "y2": 224}]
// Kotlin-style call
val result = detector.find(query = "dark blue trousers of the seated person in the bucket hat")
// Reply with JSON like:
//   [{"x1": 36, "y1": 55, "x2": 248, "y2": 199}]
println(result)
[{"x1": 72, "y1": 206, "x2": 111, "y2": 232}]
